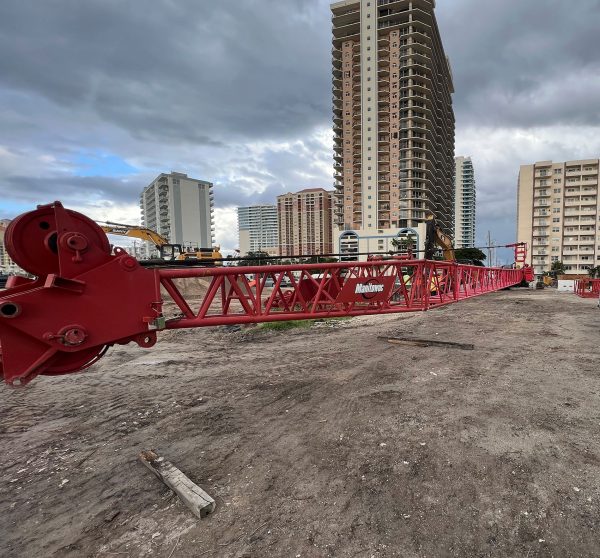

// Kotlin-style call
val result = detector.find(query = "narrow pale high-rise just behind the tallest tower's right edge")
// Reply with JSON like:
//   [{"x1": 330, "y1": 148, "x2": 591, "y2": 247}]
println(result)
[{"x1": 454, "y1": 157, "x2": 476, "y2": 248}]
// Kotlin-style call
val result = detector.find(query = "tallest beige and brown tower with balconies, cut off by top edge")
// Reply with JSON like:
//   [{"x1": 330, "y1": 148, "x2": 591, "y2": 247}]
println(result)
[{"x1": 331, "y1": 0, "x2": 454, "y2": 260}]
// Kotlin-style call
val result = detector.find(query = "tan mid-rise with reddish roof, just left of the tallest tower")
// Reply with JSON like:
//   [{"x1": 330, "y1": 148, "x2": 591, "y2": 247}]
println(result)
[{"x1": 277, "y1": 188, "x2": 333, "y2": 256}]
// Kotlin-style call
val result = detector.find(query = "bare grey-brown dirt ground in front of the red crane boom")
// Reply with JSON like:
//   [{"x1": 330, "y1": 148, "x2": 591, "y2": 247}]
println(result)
[{"x1": 0, "y1": 290, "x2": 600, "y2": 558}]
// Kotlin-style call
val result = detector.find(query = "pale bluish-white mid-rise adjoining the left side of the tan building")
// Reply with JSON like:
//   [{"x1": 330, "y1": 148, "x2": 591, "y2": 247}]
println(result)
[{"x1": 237, "y1": 205, "x2": 279, "y2": 256}]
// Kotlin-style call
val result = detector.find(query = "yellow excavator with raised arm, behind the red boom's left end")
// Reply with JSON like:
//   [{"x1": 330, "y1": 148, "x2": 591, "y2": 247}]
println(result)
[{"x1": 98, "y1": 221, "x2": 223, "y2": 265}]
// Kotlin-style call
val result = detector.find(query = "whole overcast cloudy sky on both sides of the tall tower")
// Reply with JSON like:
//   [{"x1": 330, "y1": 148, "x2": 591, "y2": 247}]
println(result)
[{"x1": 0, "y1": 0, "x2": 600, "y2": 258}]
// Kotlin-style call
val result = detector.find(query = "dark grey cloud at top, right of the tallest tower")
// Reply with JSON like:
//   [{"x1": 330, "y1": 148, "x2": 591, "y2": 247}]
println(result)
[{"x1": 437, "y1": 0, "x2": 600, "y2": 128}]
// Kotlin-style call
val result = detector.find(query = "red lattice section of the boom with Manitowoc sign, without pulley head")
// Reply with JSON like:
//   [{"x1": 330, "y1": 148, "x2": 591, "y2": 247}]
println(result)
[{"x1": 157, "y1": 260, "x2": 523, "y2": 329}]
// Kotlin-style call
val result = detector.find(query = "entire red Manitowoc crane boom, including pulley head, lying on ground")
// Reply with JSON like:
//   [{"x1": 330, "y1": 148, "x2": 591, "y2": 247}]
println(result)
[{"x1": 0, "y1": 202, "x2": 533, "y2": 385}]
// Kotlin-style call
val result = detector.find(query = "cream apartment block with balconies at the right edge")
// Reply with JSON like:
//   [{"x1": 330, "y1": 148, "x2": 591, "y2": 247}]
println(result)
[{"x1": 517, "y1": 159, "x2": 600, "y2": 274}]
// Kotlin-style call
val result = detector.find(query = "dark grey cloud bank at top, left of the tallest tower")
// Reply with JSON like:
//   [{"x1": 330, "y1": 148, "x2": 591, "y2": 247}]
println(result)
[{"x1": 0, "y1": 0, "x2": 330, "y2": 145}]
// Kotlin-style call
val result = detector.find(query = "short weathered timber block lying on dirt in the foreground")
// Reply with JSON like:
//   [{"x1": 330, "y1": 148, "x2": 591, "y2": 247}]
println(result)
[{"x1": 140, "y1": 450, "x2": 215, "y2": 518}]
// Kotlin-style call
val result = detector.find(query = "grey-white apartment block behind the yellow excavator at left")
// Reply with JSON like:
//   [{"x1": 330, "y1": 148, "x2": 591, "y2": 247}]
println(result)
[{"x1": 140, "y1": 172, "x2": 214, "y2": 258}]
